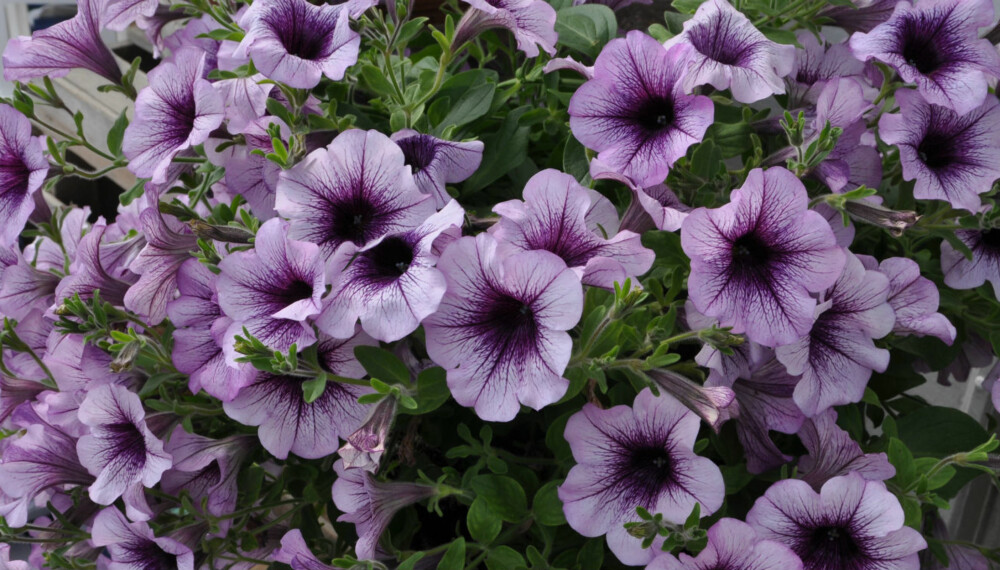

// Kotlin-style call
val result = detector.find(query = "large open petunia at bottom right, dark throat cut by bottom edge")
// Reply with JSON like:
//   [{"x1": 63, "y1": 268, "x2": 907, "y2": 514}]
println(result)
[{"x1": 747, "y1": 473, "x2": 927, "y2": 570}]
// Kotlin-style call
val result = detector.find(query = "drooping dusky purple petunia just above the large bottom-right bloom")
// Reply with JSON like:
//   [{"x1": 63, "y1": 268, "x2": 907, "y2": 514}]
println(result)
[{"x1": 799, "y1": 410, "x2": 896, "y2": 491}]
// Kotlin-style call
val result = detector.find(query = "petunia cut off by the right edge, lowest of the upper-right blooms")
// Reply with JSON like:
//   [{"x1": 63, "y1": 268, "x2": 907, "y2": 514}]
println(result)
[{"x1": 941, "y1": 229, "x2": 1000, "y2": 299}]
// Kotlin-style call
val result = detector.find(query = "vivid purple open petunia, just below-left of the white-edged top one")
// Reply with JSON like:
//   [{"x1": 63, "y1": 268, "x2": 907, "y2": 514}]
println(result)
[{"x1": 569, "y1": 31, "x2": 715, "y2": 186}]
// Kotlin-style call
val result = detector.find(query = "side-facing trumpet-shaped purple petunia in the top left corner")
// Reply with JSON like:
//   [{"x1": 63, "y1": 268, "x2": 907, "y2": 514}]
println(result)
[{"x1": 3, "y1": 0, "x2": 122, "y2": 83}]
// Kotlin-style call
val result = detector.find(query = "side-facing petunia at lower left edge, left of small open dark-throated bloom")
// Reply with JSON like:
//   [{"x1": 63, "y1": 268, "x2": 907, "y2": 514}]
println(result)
[{"x1": 0, "y1": 402, "x2": 94, "y2": 528}]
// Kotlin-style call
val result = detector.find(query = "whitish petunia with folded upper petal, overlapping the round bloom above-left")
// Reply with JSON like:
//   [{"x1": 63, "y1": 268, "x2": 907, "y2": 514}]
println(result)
[{"x1": 316, "y1": 200, "x2": 465, "y2": 342}]
